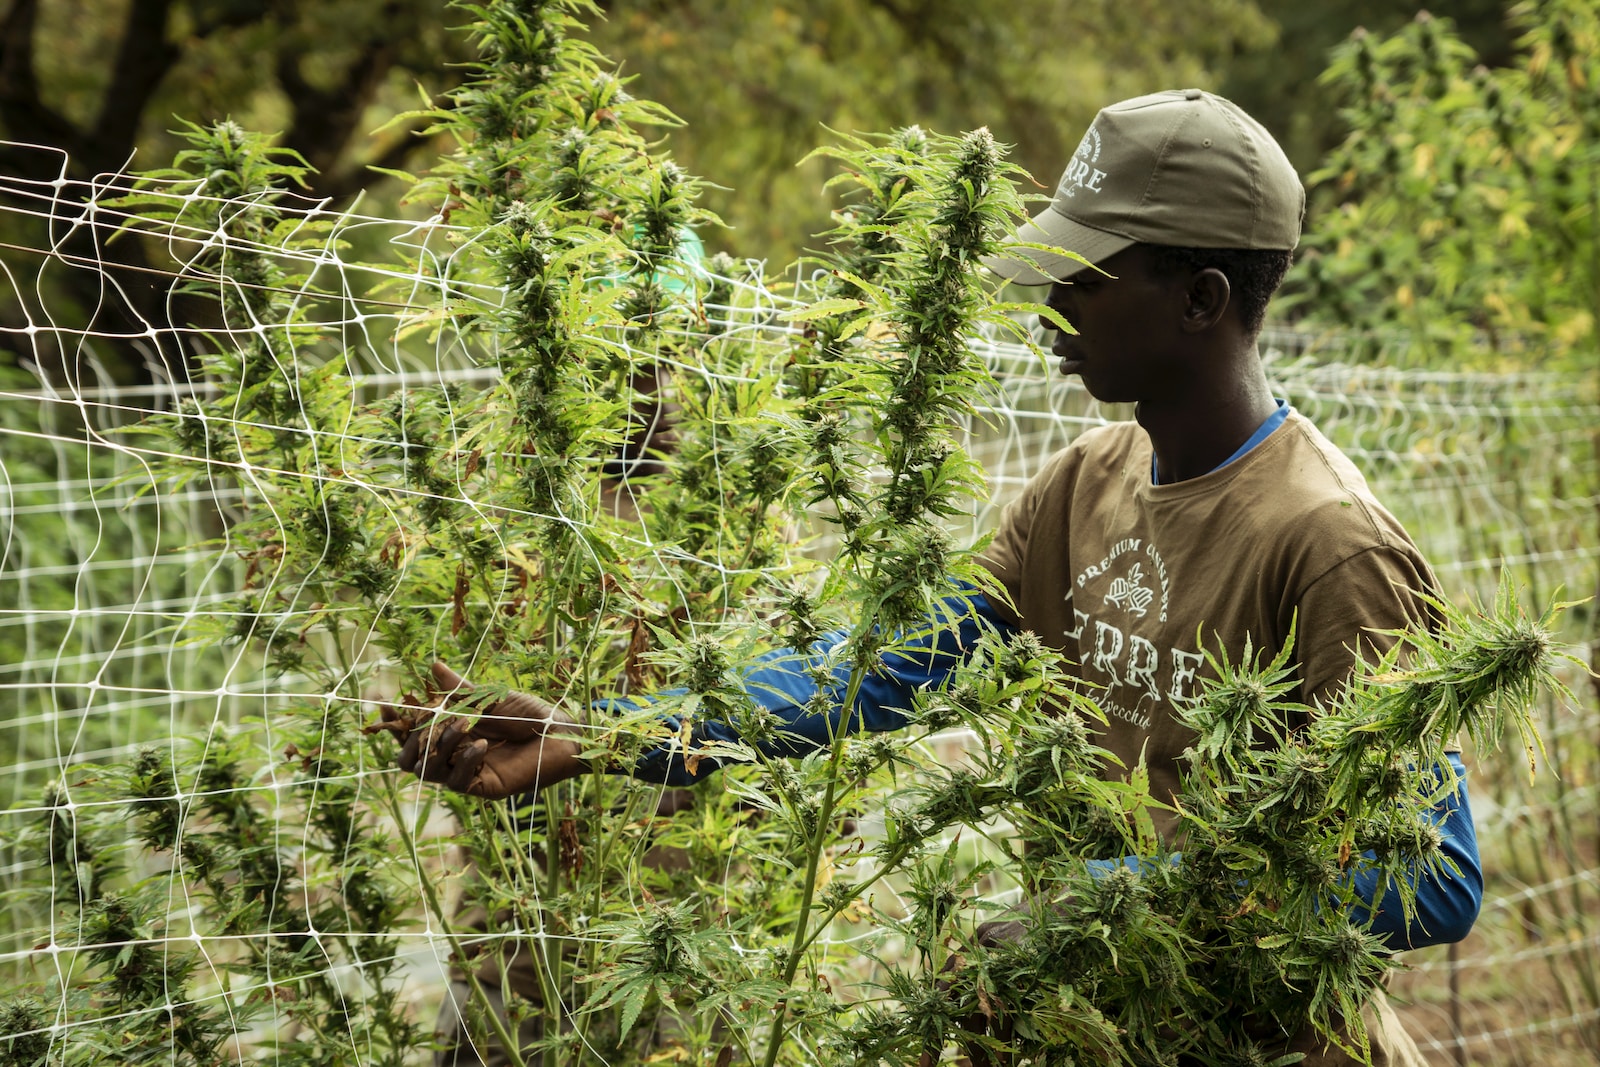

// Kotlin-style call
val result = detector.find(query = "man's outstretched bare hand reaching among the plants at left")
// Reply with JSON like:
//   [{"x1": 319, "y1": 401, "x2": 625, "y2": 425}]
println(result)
[{"x1": 366, "y1": 662, "x2": 589, "y2": 800}]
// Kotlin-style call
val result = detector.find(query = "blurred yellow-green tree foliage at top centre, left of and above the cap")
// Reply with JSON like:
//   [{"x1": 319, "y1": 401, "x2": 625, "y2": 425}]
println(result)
[{"x1": 594, "y1": 0, "x2": 1274, "y2": 264}]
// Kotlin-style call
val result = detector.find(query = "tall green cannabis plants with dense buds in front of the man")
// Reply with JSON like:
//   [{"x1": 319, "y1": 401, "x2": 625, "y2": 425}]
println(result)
[{"x1": 0, "y1": 0, "x2": 1580, "y2": 1067}]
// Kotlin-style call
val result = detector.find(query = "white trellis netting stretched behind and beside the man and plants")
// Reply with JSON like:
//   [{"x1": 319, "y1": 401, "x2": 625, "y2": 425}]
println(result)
[{"x1": 0, "y1": 154, "x2": 1600, "y2": 1064}]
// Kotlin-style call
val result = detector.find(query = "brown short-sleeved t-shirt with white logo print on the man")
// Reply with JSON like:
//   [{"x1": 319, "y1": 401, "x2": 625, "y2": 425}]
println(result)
[{"x1": 982, "y1": 411, "x2": 1435, "y2": 833}]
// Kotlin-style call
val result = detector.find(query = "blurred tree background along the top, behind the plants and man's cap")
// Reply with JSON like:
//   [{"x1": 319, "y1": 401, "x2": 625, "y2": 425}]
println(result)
[{"x1": 0, "y1": 0, "x2": 1515, "y2": 281}]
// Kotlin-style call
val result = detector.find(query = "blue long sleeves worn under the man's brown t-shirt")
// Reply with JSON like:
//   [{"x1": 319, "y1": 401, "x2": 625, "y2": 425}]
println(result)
[{"x1": 611, "y1": 593, "x2": 1483, "y2": 949}]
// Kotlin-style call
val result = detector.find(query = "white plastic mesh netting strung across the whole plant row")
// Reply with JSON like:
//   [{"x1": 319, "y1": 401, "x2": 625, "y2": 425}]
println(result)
[{"x1": 0, "y1": 150, "x2": 1600, "y2": 1064}]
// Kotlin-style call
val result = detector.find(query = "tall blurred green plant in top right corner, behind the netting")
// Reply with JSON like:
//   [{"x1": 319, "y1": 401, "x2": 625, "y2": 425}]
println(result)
[{"x1": 1291, "y1": 0, "x2": 1600, "y2": 365}]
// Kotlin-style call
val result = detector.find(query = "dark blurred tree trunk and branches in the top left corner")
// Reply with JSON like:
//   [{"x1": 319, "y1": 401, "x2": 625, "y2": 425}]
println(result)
[{"x1": 0, "y1": 0, "x2": 464, "y2": 381}]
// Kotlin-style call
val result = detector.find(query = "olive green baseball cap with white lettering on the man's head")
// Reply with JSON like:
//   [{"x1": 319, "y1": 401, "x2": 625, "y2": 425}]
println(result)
[{"x1": 982, "y1": 90, "x2": 1306, "y2": 285}]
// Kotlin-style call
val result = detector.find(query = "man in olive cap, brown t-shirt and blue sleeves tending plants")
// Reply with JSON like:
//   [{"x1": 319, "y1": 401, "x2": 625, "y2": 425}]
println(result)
[{"x1": 384, "y1": 90, "x2": 1482, "y2": 1065}]
